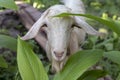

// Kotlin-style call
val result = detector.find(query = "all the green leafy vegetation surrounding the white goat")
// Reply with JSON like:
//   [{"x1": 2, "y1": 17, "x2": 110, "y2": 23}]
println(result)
[{"x1": 0, "y1": 0, "x2": 120, "y2": 80}]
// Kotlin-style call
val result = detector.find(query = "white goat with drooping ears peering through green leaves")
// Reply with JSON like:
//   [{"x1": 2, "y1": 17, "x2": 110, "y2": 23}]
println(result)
[{"x1": 22, "y1": 0, "x2": 99, "y2": 72}]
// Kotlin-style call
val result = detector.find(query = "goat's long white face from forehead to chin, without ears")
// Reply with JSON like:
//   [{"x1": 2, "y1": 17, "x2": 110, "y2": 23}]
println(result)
[{"x1": 47, "y1": 17, "x2": 73, "y2": 61}]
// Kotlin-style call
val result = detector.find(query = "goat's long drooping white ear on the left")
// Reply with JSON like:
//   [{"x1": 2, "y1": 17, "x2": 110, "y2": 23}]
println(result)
[{"x1": 21, "y1": 9, "x2": 50, "y2": 40}]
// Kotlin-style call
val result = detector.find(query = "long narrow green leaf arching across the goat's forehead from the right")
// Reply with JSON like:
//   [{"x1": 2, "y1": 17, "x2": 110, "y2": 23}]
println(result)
[{"x1": 55, "y1": 13, "x2": 120, "y2": 36}]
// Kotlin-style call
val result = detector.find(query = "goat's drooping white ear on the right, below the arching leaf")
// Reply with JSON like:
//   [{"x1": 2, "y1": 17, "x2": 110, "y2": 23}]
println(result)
[{"x1": 74, "y1": 17, "x2": 100, "y2": 35}]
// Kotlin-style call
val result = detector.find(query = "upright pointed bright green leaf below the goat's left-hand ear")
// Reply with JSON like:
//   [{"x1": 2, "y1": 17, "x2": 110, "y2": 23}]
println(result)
[{"x1": 17, "y1": 38, "x2": 48, "y2": 80}]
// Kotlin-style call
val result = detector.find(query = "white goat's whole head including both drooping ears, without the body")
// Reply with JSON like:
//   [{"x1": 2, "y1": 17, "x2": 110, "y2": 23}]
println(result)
[{"x1": 22, "y1": 5, "x2": 98, "y2": 61}]
